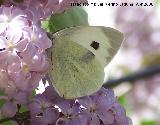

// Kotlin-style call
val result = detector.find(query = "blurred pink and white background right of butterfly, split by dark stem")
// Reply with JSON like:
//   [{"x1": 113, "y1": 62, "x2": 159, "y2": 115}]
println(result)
[{"x1": 85, "y1": 0, "x2": 160, "y2": 125}]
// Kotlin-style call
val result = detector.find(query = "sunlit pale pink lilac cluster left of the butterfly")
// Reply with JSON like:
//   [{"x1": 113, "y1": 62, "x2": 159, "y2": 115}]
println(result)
[{"x1": 0, "y1": 0, "x2": 86, "y2": 118}]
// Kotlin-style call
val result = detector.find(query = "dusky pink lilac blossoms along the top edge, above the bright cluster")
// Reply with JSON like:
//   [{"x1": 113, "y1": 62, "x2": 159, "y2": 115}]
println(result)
[{"x1": 4, "y1": 0, "x2": 87, "y2": 20}]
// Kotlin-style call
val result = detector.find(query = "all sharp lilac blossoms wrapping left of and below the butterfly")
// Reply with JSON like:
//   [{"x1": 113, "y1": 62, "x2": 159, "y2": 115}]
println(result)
[{"x1": 0, "y1": 0, "x2": 132, "y2": 125}]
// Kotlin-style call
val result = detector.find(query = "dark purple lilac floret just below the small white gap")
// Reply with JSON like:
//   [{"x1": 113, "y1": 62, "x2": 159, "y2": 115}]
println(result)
[{"x1": 29, "y1": 94, "x2": 59, "y2": 125}]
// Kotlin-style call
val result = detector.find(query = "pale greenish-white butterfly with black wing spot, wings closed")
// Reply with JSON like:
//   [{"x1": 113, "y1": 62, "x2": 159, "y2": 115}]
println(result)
[{"x1": 48, "y1": 26, "x2": 123, "y2": 99}]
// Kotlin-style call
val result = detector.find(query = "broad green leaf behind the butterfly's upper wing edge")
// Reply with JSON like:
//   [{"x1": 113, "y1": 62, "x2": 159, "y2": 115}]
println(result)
[{"x1": 42, "y1": 7, "x2": 89, "y2": 32}]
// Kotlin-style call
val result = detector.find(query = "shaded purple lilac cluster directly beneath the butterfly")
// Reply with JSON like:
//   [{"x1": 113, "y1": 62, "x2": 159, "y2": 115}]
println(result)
[{"x1": 29, "y1": 86, "x2": 132, "y2": 125}]
